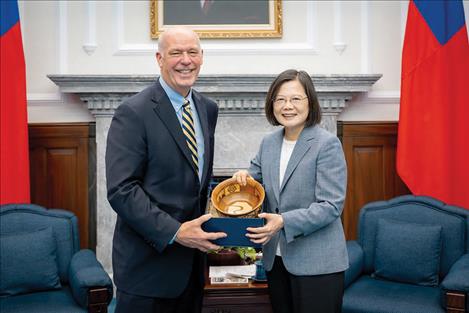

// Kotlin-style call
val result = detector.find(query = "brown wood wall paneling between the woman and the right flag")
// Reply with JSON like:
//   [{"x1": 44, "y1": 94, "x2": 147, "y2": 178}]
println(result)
[{"x1": 338, "y1": 122, "x2": 410, "y2": 240}]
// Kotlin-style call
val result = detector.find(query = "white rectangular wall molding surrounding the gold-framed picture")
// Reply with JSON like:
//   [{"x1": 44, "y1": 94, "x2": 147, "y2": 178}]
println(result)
[{"x1": 114, "y1": 1, "x2": 317, "y2": 56}]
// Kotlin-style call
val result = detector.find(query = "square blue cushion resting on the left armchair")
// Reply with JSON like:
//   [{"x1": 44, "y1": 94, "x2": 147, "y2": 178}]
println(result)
[{"x1": 0, "y1": 227, "x2": 61, "y2": 296}]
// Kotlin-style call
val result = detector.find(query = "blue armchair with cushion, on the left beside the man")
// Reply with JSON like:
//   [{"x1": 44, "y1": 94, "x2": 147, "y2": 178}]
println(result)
[{"x1": 0, "y1": 204, "x2": 113, "y2": 313}]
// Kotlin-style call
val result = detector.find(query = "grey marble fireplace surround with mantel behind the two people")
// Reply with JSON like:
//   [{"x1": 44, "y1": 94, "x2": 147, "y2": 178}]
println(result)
[{"x1": 48, "y1": 74, "x2": 381, "y2": 274}]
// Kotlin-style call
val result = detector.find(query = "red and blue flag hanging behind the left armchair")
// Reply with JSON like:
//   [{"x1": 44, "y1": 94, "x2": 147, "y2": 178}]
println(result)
[{"x1": 0, "y1": 0, "x2": 30, "y2": 204}]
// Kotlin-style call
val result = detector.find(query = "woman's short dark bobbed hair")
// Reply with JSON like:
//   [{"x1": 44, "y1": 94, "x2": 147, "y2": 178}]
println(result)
[{"x1": 265, "y1": 70, "x2": 321, "y2": 127}]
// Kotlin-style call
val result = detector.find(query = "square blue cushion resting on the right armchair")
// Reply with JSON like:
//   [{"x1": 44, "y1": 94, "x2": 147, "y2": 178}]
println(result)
[{"x1": 374, "y1": 219, "x2": 441, "y2": 286}]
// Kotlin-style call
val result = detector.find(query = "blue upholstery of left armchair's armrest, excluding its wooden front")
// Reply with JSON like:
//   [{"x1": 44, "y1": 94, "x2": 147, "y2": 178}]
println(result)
[{"x1": 69, "y1": 249, "x2": 113, "y2": 308}]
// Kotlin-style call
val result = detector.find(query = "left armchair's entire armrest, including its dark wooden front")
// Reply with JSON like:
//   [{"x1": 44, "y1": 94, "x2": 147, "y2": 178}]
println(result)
[{"x1": 68, "y1": 249, "x2": 113, "y2": 311}]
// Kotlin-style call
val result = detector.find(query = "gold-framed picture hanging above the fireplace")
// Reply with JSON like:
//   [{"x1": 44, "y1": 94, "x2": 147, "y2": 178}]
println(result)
[{"x1": 150, "y1": 0, "x2": 282, "y2": 39}]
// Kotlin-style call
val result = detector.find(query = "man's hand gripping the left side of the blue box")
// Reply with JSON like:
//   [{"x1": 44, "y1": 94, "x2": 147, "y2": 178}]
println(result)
[{"x1": 176, "y1": 214, "x2": 226, "y2": 252}]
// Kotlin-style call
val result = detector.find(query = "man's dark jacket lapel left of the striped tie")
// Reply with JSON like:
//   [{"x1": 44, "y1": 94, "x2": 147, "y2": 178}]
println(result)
[{"x1": 152, "y1": 81, "x2": 196, "y2": 172}]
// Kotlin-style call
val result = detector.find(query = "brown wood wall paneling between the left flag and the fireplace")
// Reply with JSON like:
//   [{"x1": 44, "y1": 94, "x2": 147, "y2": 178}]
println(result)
[{"x1": 29, "y1": 123, "x2": 96, "y2": 248}]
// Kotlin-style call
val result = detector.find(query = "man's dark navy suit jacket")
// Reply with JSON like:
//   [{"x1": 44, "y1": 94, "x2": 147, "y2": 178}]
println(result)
[{"x1": 106, "y1": 81, "x2": 218, "y2": 298}]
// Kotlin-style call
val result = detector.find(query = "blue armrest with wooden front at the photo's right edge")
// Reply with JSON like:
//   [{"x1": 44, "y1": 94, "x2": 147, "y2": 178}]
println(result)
[{"x1": 441, "y1": 254, "x2": 469, "y2": 312}]
